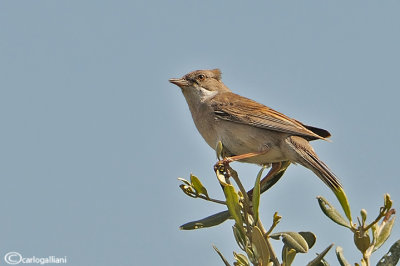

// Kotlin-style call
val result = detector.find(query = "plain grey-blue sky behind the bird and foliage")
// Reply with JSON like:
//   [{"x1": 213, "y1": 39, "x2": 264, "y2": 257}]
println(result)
[{"x1": 0, "y1": 0, "x2": 400, "y2": 266}]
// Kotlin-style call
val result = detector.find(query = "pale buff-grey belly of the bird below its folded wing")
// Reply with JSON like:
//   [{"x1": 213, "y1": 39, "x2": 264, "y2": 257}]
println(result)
[{"x1": 217, "y1": 121, "x2": 288, "y2": 164}]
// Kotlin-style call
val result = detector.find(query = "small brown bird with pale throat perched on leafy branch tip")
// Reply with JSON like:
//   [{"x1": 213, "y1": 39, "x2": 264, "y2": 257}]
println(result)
[{"x1": 169, "y1": 69, "x2": 342, "y2": 194}]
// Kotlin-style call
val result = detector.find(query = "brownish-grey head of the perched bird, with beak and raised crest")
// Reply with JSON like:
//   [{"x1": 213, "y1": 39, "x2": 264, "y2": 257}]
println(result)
[{"x1": 169, "y1": 69, "x2": 230, "y2": 94}]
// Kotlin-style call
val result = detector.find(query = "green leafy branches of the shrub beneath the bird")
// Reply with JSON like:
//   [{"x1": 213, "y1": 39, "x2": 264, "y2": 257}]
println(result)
[{"x1": 179, "y1": 141, "x2": 400, "y2": 266}]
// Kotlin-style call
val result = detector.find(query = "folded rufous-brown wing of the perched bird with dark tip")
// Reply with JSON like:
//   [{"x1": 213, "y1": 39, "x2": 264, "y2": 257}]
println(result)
[{"x1": 210, "y1": 92, "x2": 330, "y2": 140}]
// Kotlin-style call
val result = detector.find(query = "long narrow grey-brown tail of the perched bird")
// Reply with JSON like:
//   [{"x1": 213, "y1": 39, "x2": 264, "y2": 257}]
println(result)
[{"x1": 286, "y1": 136, "x2": 343, "y2": 194}]
